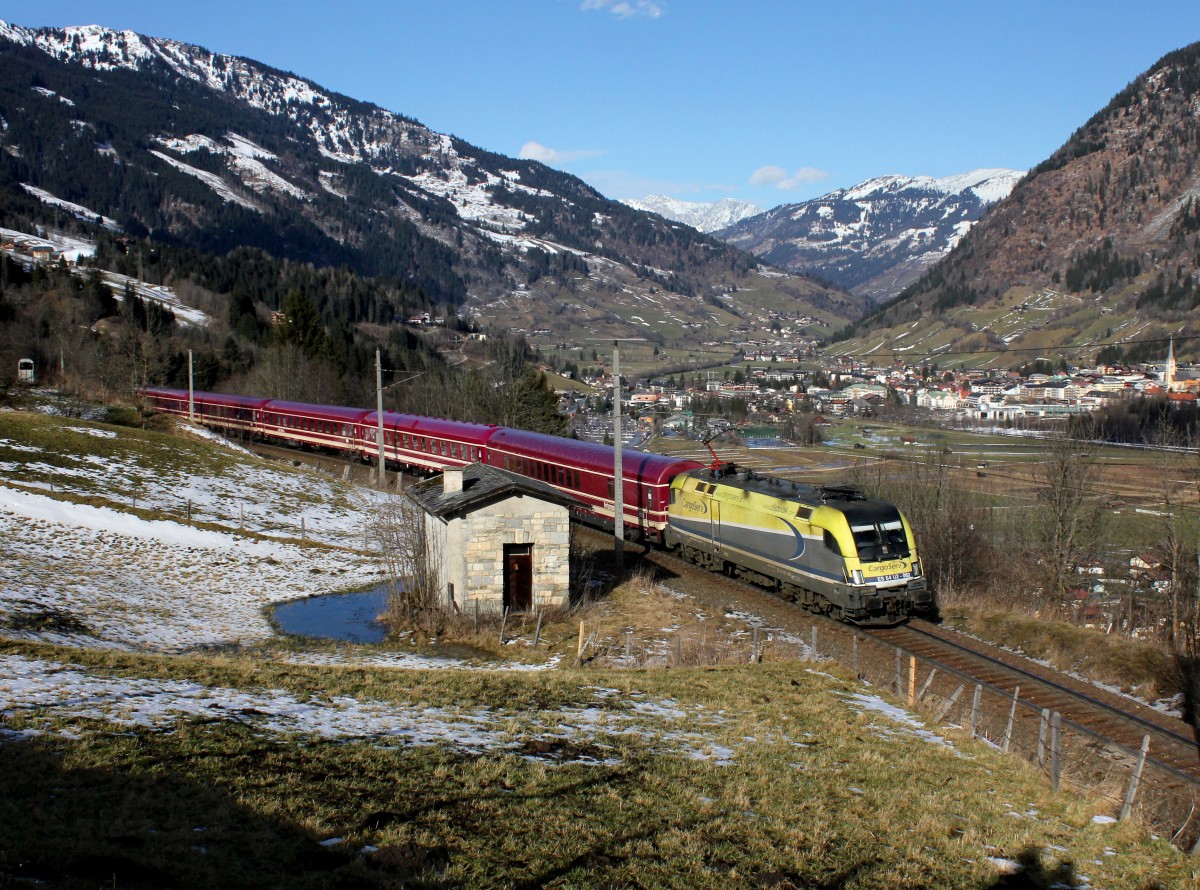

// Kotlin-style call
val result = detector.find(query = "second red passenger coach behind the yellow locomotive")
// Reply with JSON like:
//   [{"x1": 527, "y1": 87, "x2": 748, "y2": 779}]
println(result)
[{"x1": 362, "y1": 411, "x2": 499, "y2": 473}]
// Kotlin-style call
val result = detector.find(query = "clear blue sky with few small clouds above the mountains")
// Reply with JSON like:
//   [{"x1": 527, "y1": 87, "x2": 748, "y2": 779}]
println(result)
[{"x1": 9, "y1": 0, "x2": 1200, "y2": 208}]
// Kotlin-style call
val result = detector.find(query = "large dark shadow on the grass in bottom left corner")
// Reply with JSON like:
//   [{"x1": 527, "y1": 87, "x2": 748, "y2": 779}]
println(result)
[{"x1": 0, "y1": 736, "x2": 386, "y2": 890}]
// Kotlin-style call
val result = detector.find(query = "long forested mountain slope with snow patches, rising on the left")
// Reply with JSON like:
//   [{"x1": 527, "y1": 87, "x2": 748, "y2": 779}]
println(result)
[{"x1": 0, "y1": 23, "x2": 858, "y2": 336}]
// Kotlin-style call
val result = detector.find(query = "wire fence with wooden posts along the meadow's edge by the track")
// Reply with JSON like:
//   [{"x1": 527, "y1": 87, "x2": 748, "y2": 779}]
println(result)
[{"x1": 577, "y1": 623, "x2": 1200, "y2": 853}]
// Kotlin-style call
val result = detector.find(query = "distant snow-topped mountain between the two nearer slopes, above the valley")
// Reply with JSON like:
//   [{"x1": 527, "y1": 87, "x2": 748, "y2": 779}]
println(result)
[{"x1": 714, "y1": 169, "x2": 1025, "y2": 300}]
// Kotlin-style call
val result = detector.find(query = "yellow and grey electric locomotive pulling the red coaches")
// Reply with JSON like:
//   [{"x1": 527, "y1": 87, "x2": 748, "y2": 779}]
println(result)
[{"x1": 664, "y1": 464, "x2": 934, "y2": 625}]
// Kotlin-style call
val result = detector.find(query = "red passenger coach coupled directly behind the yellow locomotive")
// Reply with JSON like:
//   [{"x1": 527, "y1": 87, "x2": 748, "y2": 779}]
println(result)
[{"x1": 487, "y1": 427, "x2": 704, "y2": 542}]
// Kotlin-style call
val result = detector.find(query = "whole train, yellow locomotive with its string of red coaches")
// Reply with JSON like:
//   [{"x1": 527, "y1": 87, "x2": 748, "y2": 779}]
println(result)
[{"x1": 140, "y1": 387, "x2": 936, "y2": 625}]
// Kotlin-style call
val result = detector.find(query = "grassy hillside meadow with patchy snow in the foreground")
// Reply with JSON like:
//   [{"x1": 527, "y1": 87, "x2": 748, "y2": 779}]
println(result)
[{"x1": 0, "y1": 411, "x2": 1200, "y2": 888}]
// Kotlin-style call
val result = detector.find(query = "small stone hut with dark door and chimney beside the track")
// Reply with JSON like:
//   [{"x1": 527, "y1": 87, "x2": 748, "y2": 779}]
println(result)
[{"x1": 407, "y1": 463, "x2": 578, "y2": 612}]
